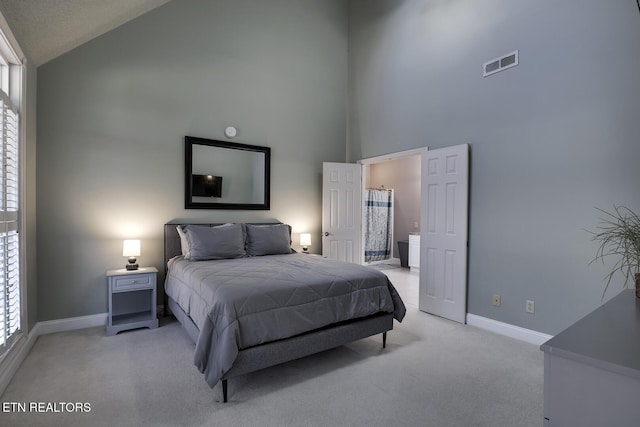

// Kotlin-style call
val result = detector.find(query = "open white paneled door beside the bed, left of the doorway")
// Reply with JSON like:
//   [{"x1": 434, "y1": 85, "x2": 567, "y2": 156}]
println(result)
[{"x1": 322, "y1": 162, "x2": 362, "y2": 264}]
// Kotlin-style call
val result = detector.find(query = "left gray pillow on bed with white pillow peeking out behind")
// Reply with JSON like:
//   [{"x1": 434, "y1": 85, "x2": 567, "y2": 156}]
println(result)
[{"x1": 178, "y1": 224, "x2": 247, "y2": 261}]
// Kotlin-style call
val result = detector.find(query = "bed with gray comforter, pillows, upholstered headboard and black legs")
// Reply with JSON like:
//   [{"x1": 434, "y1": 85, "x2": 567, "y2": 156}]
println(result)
[{"x1": 164, "y1": 223, "x2": 406, "y2": 402}]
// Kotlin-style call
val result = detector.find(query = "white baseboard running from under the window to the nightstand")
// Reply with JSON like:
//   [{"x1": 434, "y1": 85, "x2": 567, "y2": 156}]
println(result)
[{"x1": 0, "y1": 313, "x2": 108, "y2": 396}]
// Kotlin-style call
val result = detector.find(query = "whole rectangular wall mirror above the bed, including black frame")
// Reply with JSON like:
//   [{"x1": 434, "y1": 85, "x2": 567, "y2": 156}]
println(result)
[{"x1": 184, "y1": 136, "x2": 271, "y2": 210}]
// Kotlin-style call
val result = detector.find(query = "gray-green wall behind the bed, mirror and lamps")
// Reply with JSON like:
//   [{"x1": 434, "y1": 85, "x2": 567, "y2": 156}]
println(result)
[{"x1": 37, "y1": 0, "x2": 347, "y2": 320}]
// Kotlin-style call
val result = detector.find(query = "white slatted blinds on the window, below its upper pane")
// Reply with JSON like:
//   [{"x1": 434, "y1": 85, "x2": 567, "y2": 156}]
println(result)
[{"x1": 0, "y1": 91, "x2": 21, "y2": 353}]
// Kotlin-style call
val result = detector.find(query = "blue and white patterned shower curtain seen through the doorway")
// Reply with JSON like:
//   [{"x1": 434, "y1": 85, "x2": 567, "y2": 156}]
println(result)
[{"x1": 364, "y1": 188, "x2": 393, "y2": 262}]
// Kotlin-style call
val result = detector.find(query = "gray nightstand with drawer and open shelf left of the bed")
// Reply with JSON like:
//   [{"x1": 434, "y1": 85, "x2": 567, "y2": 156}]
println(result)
[{"x1": 107, "y1": 267, "x2": 158, "y2": 335}]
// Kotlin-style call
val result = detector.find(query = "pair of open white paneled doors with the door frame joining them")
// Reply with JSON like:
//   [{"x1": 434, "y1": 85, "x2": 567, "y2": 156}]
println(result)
[{"x1": 322, "y1": 144, "x2": 469, "y2": 323}]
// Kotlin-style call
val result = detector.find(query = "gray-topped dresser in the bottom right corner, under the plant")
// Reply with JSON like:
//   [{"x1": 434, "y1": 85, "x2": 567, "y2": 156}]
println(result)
[{"x1": 540, "y1": 290, "x2": 640, "y2": 427}]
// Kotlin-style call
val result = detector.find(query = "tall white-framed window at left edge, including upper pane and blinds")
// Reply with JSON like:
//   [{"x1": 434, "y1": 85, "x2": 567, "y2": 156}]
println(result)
[{"x1": 0, "y1": 15, "x2": 24, "y2": 357}]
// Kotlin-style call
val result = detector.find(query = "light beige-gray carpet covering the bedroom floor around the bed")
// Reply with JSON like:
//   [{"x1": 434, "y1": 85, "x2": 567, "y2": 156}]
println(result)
[{"x1": 0, "y1": 270, "x2": 543, "y2": 427}]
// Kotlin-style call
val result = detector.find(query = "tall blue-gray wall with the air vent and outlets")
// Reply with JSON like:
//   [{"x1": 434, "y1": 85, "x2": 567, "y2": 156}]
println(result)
[{"x1": 348, "y1": 0, "x2": 640, "y2": 334}]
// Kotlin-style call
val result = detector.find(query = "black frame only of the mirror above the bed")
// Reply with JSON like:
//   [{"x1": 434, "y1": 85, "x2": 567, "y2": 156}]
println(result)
[{"x1": 184, "y1": 136, "x2": 271, "y2": 210}]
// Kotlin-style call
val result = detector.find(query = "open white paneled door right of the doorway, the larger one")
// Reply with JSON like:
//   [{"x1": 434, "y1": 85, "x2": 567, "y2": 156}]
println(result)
[{"x1": 418, "y1": 144, "x2": 469, "y2": 323}]
